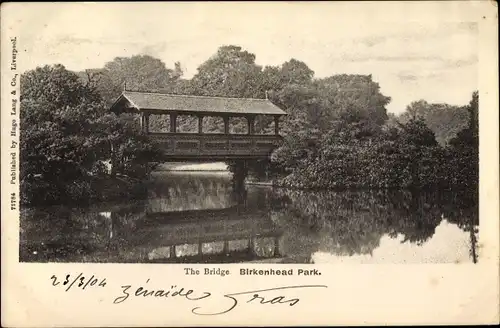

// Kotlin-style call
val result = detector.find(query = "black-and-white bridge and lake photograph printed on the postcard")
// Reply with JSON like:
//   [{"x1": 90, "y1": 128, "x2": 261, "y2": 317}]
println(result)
[{"x1": 11, "y1": 3, "x2": 481, "y2": 264}]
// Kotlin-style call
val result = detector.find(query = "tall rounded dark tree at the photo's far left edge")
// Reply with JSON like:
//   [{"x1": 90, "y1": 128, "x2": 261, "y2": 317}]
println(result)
[{"x1": 20, "y1": 65, "x2": 104, "y2": 180}]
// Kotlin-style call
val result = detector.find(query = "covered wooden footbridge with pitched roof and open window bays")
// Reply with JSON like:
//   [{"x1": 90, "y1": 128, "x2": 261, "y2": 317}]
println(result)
[{"x1": 111, "y1": 91, "x2": 286, "y2": 161}]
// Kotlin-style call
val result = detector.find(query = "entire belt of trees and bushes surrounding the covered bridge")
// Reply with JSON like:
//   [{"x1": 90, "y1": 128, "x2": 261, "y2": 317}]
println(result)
[{"x1": 21, "y1": 45, "x2": 478, "y2": 202}]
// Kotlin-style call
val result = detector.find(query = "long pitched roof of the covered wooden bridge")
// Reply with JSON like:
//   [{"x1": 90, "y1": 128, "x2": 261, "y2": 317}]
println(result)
[{"x1": 111, "y1": 91, "x2": 287, "y2": 115}]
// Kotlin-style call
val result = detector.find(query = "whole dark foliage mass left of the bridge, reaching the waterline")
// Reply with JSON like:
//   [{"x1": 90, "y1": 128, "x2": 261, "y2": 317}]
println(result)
[{"x1": 20, "y1": 65, "x2": 161, "y2": 203}]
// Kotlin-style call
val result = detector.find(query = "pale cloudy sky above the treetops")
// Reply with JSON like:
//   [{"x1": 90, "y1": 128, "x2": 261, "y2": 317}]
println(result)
[{"x1": 5, "y1": 2, "x2": 478, "y2": 113}]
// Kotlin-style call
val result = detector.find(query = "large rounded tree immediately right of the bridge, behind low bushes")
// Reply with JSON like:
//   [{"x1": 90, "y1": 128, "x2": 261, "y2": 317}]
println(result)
[{"x1": 272, "y1": 74, "x2": 390, "y2": 178}]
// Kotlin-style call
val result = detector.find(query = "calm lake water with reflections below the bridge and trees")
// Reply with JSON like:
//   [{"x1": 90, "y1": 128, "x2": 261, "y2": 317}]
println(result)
[{"x1": 20, "y1": 172, "x2": 480, "y2": 263}]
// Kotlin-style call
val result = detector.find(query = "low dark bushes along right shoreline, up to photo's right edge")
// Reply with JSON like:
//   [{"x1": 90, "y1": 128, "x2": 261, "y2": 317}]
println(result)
[{"x1": 274, "y1": 93, "x2": 479, "y2": 189}]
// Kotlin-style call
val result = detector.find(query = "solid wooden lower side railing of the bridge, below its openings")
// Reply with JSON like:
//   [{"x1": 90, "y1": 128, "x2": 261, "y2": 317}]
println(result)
[{"x1": 149, "y1": 133, "x2": 282, "y2": 158}]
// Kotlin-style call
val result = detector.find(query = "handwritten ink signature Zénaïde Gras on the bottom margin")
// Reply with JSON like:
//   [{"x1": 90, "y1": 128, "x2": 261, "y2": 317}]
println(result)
[{"x1": 113, "y1": 279, "x2": 328, "y2": 315}]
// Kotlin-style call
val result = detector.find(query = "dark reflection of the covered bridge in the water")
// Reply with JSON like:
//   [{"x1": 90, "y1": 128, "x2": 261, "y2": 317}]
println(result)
[{"x1": 134, "y1": 206, "x2": 282, "y2": 263}]
